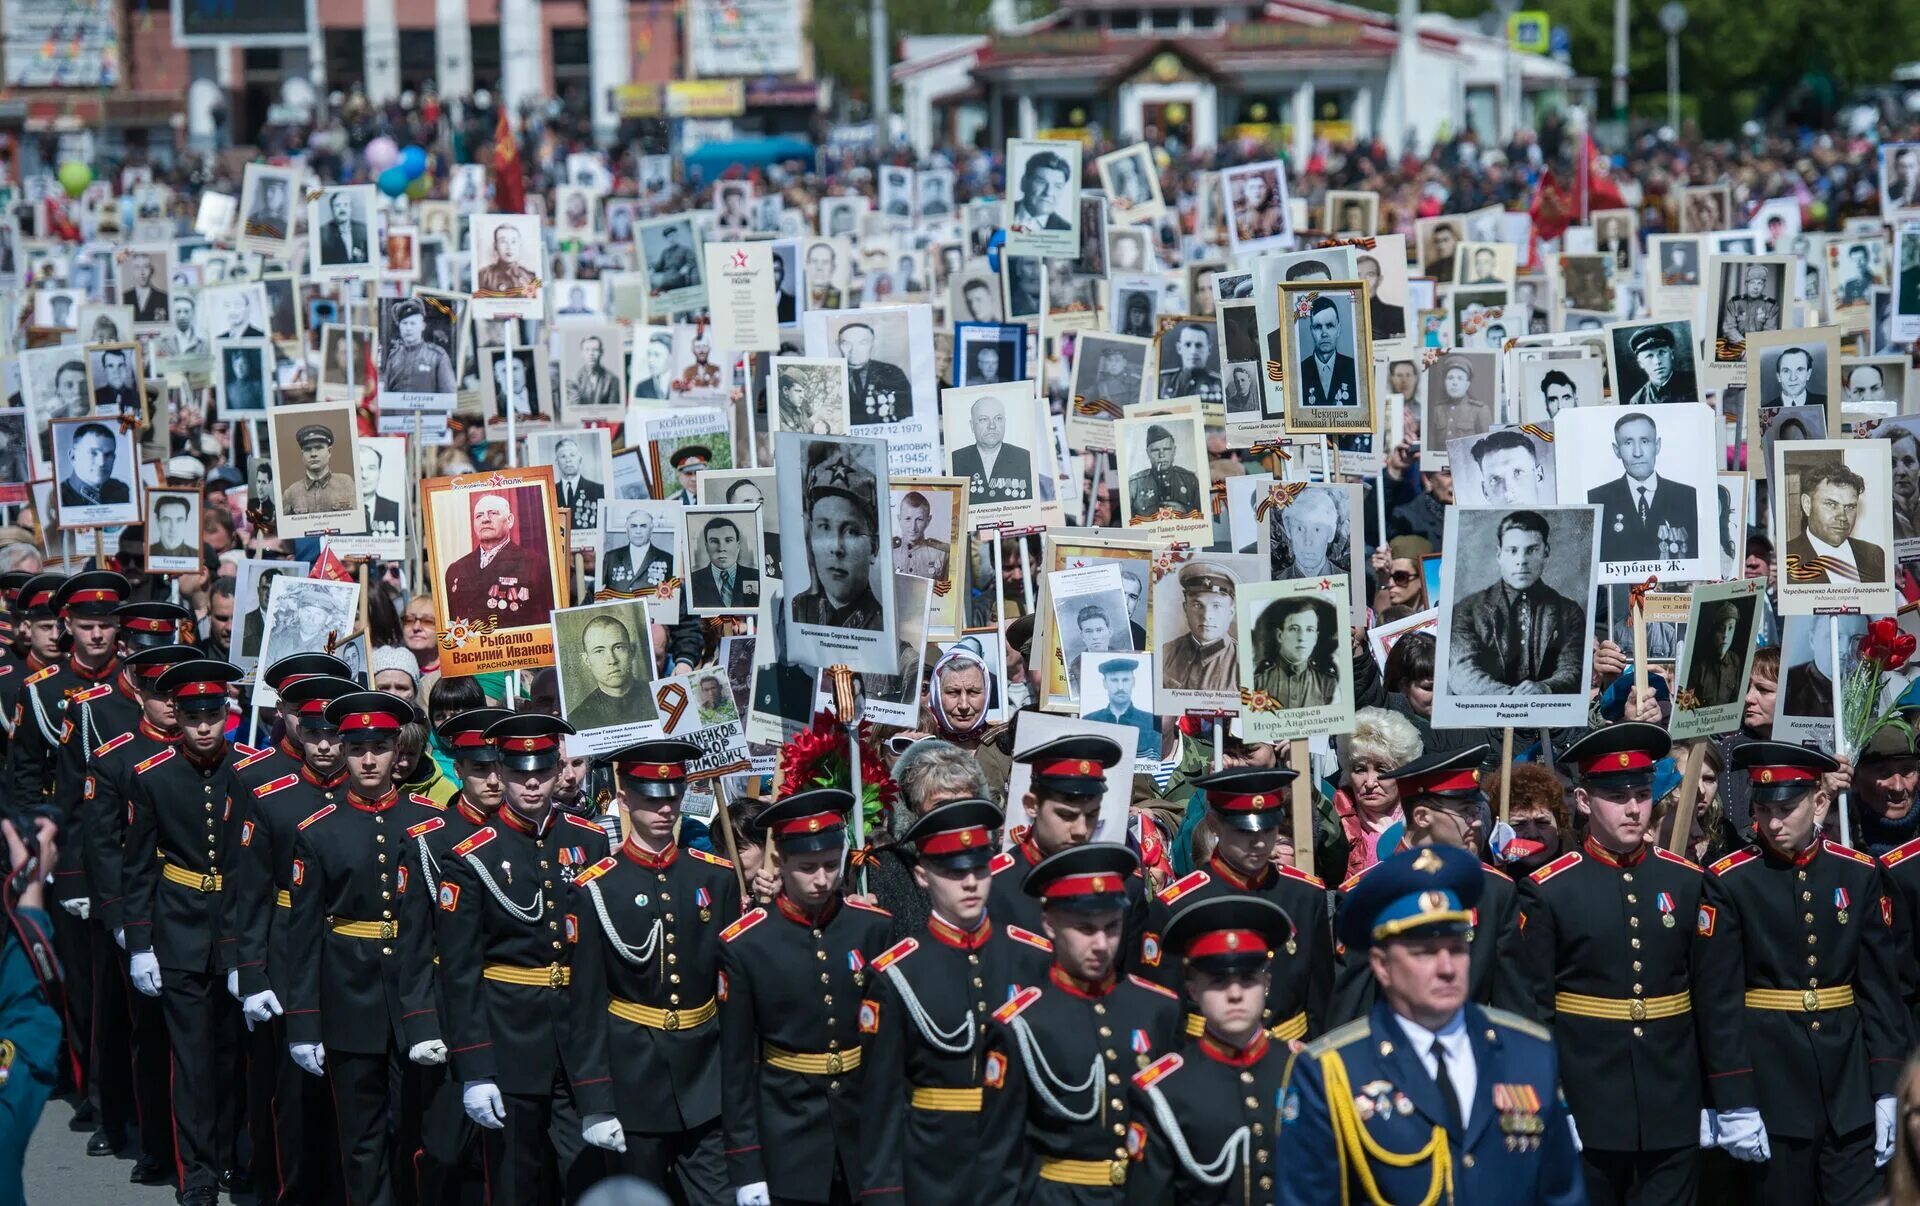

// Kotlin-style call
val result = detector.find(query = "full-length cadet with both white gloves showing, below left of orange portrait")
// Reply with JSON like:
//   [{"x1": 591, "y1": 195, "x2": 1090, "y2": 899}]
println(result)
[{"x1": 286, "y1": 691, "x2": 447, "y2": 1206}]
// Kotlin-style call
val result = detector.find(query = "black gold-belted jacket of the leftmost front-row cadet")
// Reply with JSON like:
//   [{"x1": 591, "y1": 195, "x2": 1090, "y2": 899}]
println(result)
[{"x1": 120, "y1": 741, "x2": 246, "y2": 974}]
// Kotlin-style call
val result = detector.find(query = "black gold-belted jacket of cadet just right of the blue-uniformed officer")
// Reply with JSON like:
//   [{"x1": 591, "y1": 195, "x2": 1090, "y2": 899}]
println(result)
[{"x1": 1521, "y1": 841, "x2": 1759, "y2": 1152}]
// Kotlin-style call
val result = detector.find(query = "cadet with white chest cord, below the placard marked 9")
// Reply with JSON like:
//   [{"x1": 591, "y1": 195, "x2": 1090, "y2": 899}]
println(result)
[{"x1": 566, "y1": 741, "x2": 741, "y2": 1202}]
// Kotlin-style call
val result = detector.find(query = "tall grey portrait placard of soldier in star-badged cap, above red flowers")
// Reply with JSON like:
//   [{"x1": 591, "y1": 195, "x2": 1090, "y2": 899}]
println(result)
[{"x1": 774, "y1": 432, "x2": 899, "y2": 674}]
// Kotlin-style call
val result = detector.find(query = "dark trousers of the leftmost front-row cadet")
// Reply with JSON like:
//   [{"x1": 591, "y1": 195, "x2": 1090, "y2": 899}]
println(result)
[{"x1": 161, "y1": 968, "x2": 240, "y2": 1193}]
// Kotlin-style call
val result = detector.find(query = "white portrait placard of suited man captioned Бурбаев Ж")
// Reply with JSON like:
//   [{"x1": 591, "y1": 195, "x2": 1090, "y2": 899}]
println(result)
[{"x1": 1553, "y1": 405, "x2": 1722, "y2": 582}]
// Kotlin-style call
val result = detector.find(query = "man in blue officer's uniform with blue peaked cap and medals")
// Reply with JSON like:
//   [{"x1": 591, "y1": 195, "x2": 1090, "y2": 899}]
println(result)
[{"x1": 1273, "y1": 845, "x2": 1589, "y2": 1206}]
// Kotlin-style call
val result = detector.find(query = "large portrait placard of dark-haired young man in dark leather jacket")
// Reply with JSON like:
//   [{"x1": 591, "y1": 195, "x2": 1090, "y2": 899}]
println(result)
[{"x1": 1432, "y1": 507, "x2": 1599, "y2": 726}]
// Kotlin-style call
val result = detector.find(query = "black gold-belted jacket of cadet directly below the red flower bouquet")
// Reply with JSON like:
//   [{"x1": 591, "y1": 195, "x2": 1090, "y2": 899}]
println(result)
[{"x1": 720, "y1": 895, "x2": 891, "y2": 1202}]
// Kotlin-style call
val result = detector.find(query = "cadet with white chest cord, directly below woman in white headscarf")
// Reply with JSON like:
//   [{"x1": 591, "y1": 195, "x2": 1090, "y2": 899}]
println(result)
[{"x1": 860, "y1": 799, "x2": 1052, "y2": 1206}]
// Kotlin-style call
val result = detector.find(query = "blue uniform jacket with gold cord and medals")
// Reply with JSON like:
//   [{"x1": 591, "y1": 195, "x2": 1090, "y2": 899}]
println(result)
[{"x1": 1273, "y1": 1002, "x2": 1582, "y2": 1206}]
